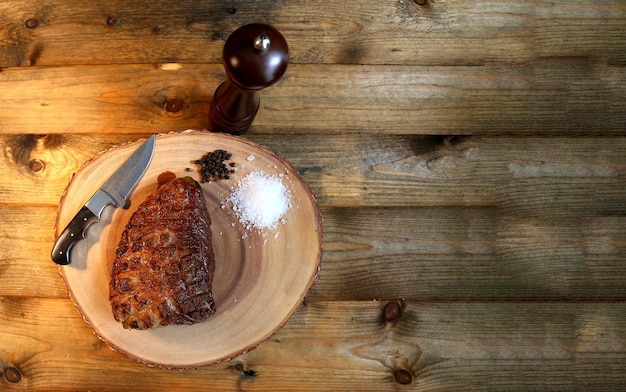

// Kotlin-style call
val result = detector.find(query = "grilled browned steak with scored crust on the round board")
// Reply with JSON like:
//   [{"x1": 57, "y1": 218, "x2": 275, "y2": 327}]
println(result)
[{"x1": 109, "y1": 177, "x2": 215, "y2": 329}]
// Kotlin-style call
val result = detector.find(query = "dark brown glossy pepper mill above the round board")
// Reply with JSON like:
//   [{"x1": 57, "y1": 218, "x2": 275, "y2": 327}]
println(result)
[{"x1": 209, "y1": 23, "x2": 289, "y2": 135}]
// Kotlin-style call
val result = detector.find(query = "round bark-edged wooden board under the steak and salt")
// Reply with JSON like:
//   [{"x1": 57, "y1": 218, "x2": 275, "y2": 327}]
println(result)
[{"x1": 56, "y1": 131, "x2": 322, "y2": 368}]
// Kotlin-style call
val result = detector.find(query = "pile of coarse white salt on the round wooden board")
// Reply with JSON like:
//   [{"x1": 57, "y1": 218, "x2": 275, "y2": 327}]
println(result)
[{"x1": 227, "y1": 171, "x2": 291, "y2": 230}]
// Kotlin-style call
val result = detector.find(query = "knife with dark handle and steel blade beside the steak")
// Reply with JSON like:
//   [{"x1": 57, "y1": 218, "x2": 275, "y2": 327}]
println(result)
[{"x1": 52, "y1": 135, "x2": 156, "y2": 265}]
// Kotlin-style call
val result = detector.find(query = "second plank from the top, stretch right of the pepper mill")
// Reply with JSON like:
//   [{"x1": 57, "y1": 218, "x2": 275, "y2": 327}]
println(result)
[{"x1": 254, "y1": 58, "x2": 626, "y2": 135}]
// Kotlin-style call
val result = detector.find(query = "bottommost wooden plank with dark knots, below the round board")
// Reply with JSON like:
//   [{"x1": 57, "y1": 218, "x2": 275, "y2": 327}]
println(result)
[{"x1": 0, "y1": 297, "x2": 626, "y2": 391}]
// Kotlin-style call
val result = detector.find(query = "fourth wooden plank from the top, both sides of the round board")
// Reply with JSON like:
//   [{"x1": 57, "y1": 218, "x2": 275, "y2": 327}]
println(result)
[{"x1": 0, "y1": 205, "x2": 626, "y2": 301}]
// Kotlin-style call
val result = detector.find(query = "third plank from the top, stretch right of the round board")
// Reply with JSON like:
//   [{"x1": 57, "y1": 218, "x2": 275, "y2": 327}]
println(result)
[{"x1": 251, "y1": 135, "x2": 626, "y2": 211}]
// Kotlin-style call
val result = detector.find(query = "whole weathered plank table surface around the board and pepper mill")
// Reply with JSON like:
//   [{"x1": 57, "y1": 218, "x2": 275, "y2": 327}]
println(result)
[{"x1": 0, "y1": 0, "x2": 626, "y2": 391}]
